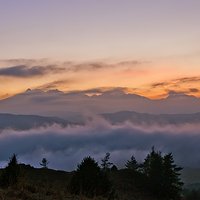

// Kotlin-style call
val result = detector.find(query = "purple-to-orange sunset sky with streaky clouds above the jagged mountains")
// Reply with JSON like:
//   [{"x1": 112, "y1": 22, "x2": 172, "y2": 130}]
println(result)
[{"x1": 0, "y1": 0, "x2": 200, "y2": 99}]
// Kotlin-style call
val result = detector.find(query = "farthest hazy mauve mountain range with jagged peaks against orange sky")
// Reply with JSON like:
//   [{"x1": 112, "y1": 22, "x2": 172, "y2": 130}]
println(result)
[{"x1": 0, "y1": 88, "x2": 200, "y2": 117}]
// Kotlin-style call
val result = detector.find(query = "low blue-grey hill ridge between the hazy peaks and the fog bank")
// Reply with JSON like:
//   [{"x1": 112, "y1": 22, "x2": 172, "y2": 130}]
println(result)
[{"x1": 0, "y1": 111, "x2": 200, "y2": 130}]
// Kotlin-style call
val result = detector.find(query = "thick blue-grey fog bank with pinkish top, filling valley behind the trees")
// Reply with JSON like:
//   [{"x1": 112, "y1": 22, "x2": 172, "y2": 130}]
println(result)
[{"x1": 0, "y1": 118, "x2": 200, "y2": 170}]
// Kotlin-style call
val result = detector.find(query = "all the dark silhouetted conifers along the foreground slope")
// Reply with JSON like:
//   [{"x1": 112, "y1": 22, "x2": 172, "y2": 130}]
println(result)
[{"x1": 0, "y1": 147, "x2": 183, "y2": 200}]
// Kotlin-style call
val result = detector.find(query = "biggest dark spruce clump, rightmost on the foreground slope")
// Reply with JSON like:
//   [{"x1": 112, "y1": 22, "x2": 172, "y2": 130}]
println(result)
[{"x1": 143, "y1": 147, "x2": 183, "y2": 200}]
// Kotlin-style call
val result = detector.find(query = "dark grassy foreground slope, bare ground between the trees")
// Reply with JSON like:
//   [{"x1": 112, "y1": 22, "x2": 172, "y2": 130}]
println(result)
[{"x1": 0, "y1": 165, "x2": 153, "y2": 200}]
